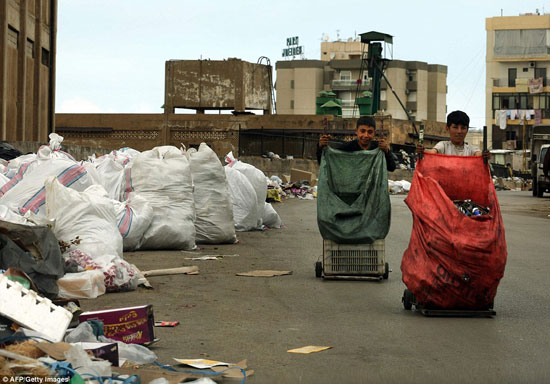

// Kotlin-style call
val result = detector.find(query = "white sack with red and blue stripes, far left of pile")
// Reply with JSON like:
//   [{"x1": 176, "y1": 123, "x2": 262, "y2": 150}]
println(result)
[{"x1": 0, "y1": 158, "x2": 98, "y2": 214}]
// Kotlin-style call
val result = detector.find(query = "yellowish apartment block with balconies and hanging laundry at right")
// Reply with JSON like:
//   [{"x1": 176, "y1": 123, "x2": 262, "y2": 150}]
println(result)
[{"x1": 485, "y1": 13, "x2": 550, "y2": 149}]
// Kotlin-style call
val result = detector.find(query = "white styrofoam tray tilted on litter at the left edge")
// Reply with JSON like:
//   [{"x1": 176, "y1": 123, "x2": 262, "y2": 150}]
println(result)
[{"x1": 0, "y1": 274, "x2": 73, "y2": 342}]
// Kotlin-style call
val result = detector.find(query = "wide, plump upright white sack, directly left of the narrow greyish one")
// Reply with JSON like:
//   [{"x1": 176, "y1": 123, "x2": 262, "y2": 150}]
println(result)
[{"x1": 121, "y1": 146, "x2": 196, "y2": 250}]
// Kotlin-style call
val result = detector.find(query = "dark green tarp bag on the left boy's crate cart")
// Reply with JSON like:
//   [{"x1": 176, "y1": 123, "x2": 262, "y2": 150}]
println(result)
[{"x1": 317, "y1": 147, "x2": 391, "y2": 244}]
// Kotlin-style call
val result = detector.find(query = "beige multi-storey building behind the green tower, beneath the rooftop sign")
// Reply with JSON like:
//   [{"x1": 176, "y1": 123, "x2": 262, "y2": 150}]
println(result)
[{"x1": 276, "y1": 40, "x2": 447, "y2": 121}]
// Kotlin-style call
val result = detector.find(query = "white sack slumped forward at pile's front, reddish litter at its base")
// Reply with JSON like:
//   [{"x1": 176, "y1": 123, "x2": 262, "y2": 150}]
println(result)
[{"x1": 46, "y1": 177, "x2": 138, "y2": 291}]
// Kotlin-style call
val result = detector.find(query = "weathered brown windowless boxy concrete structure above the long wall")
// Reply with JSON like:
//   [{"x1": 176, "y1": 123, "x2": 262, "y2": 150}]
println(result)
[{"x1": 164, "y1": 59, "x2": 272, "y2": 114}]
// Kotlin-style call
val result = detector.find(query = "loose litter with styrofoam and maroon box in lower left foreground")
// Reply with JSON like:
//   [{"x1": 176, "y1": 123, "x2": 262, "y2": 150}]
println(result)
[{"x1": 0, "y1": 288, "x2": 254, "y2": 384}]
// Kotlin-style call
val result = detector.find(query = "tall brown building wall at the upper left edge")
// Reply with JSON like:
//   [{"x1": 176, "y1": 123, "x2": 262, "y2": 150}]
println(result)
[{"x1": 0, "y1": 0, "x2": 57, "y2": 141}]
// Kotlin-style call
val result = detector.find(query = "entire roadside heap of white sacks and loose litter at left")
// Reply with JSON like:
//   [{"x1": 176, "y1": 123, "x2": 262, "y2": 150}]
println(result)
[{"x1": 0, "y1": 134, "x2": 276, "y2": 384}]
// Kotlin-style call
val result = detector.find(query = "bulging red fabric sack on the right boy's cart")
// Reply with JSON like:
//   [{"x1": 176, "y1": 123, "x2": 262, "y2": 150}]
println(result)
[{"x1": 401, "y1": 153, "x2": 507, "y2": 309}]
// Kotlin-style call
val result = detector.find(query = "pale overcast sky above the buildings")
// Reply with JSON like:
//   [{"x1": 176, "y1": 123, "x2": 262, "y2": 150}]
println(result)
[{"x1": 56, "y1": 0, "x2": 550, "y2": 127}]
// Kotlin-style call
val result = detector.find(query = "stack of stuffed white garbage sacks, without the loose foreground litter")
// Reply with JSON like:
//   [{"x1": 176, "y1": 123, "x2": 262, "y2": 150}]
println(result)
[{"x1": 0, "y1": 133, "x2": 282, "y2": 298}]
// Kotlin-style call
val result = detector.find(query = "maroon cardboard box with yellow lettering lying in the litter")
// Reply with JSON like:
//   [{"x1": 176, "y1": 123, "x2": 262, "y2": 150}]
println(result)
[{"x1": 79, "y1": 304, "x2": 155, "y2": 344}]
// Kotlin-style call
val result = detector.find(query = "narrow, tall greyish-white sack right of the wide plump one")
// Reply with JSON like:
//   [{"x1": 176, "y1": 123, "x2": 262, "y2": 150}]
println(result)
[{"x1": 190, "y1": 143, "x2": 237, "y2": 244}]
